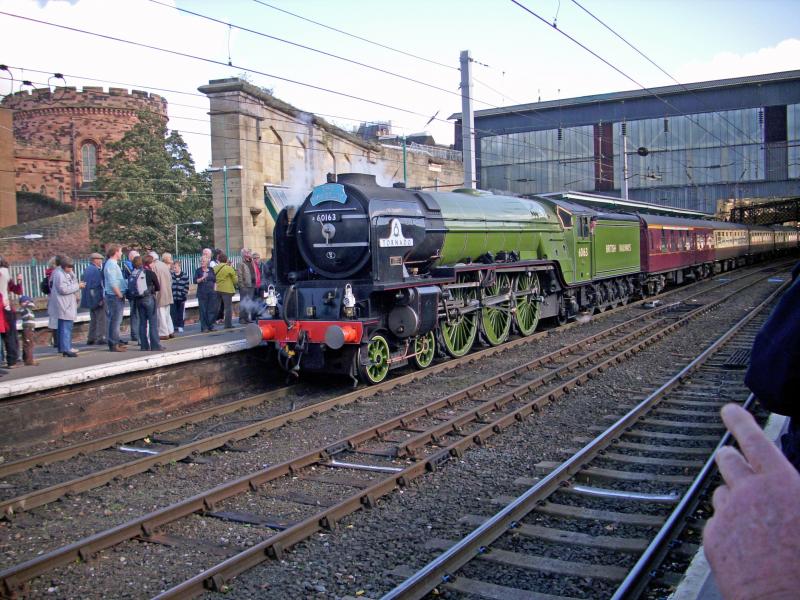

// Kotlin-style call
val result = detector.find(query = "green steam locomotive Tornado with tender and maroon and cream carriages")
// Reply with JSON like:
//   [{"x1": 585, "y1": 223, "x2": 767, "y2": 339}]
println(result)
[{"x1": 248, "y1": 174, "x2": 798, "y2": 384}]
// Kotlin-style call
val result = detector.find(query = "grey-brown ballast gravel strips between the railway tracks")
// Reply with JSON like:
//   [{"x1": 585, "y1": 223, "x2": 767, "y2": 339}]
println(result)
[{"x1": 0, "y1": 266, "x2": 780, "y2": 598}]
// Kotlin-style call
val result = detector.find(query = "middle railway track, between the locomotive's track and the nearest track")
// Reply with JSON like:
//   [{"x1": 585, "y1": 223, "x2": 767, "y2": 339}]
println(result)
[{"x1": 0, "y1": 260, "x2": 788, "y2": 597}]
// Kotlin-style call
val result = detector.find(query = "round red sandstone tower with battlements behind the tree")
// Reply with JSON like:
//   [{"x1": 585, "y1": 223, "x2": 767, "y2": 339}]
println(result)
[{"x1": 2, "y1": 87, "x2": 167, "y2": 217}]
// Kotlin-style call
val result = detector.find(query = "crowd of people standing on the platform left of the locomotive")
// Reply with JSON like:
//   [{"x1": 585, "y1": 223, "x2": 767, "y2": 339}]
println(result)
[{"x1": 0, "y1": 244, "x2": 273, "y2": 369}]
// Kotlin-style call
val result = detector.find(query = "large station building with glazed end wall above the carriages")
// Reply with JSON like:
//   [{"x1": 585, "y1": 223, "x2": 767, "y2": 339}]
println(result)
[{"x1": 451, "y1": 71, "x2": 800, "y2": 215}]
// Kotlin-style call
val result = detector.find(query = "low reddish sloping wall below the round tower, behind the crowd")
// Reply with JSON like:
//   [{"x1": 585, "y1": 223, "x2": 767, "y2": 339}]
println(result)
[{"x1": 0, "y1": 210, "x2": 90, "y2": 263}]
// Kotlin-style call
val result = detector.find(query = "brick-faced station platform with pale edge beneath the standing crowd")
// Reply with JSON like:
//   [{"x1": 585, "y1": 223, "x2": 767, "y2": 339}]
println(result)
[{"x1": 0, "y1": 300, "x2": 276, "y2": 445}]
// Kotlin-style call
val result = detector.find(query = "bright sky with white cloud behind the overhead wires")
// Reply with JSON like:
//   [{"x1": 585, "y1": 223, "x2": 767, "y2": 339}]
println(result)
[{"x1": 0, "y1": 0, "x2": 800, "y2": 169}]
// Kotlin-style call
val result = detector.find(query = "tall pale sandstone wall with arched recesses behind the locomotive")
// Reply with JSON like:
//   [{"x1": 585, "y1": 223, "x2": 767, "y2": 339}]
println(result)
[{"x1": 199, "y1": 78, "x2": 464, "y2": 256}]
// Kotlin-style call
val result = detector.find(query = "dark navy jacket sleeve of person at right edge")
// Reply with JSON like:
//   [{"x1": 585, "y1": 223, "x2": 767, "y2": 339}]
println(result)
[{"x1": 745, "y1": 263, "x2": 800, "y2": 471}]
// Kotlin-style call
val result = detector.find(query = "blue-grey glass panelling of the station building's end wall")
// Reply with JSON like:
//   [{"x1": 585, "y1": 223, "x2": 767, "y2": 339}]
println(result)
[{"x1": 480, "y1": 104, "x2": 800, "y2": 194}]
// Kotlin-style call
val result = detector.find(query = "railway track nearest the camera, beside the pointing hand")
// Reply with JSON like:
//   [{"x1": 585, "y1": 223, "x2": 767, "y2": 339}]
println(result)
[{"x1": 382, "y1": 284, "x2": 787, "y2": 600}]
